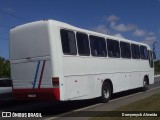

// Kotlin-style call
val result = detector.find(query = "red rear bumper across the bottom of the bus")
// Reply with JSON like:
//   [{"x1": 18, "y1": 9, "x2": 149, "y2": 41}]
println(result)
[{"x1": 13, "y1": 88, "x2": 60, "y2": 100}]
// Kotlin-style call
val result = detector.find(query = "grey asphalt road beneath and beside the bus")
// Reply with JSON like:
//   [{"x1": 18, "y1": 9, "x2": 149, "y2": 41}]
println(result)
[{"x1": 0, "y1": 77, "x2": 160, "y2": 120}]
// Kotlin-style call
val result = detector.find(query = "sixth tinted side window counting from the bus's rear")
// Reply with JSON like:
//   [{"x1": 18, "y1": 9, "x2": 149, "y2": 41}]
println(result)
[{"x1": 131, "y1": 44, "x2": 140, "y2": 59}]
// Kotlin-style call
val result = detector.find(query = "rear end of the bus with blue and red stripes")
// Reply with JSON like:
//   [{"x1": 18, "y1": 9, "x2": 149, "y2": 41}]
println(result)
[{"x1": 10, "y1": 21, "x2": 60, "y2": 100}]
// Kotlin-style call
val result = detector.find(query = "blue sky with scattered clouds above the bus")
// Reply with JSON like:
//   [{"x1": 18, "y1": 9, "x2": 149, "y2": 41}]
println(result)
[{"x1": 0, "y1": 0, "x2": 160, "y2": 59}]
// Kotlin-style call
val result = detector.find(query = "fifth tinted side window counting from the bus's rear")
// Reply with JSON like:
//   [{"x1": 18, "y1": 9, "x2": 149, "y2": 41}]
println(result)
[{"x1": 120, "y1": 42, "x2": 131, "y2": 58}]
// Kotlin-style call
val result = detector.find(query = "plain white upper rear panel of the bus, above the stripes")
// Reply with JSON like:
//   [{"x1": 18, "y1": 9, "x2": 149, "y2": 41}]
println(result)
[{"x1": 10, "y1": 24, "x2": 50, "y2": 60}]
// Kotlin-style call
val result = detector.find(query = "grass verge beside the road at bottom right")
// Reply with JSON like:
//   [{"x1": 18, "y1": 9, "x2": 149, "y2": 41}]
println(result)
[{"x1": 89, "y1": 93, "x2": 160, "y2": 120}]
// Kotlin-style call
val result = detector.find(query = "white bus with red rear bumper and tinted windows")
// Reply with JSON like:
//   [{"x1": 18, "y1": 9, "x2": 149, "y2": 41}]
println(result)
[{"x1": 10, "y1": 20, "x2": 154, "y2": 102}]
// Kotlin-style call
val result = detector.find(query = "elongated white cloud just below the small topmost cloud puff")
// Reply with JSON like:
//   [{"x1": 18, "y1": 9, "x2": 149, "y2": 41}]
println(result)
[{"x1": 110, "y1": 21, "x2": 136, "y2": 32}]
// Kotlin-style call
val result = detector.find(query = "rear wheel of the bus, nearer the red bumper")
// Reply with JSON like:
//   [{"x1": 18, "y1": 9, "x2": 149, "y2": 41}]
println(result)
[{"x1": 101, "y1": 82, "x2": 111, "y2": 103}]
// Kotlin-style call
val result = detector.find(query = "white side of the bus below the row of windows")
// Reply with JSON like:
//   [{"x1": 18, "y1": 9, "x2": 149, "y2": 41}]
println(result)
[{"x1": 62, "y1": 56, "x2": 153, "y2": 99}]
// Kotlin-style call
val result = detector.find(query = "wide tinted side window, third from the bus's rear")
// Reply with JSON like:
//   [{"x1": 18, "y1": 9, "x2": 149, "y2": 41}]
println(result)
[{"x1": 89, "y1": 35, "x2": 107, "y2": 56}]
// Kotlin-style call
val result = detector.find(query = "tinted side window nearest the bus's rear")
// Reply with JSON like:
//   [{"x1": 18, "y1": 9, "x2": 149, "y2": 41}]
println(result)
[{"x1": 60, "y1": 29, "x2": 77, "y2": 55}]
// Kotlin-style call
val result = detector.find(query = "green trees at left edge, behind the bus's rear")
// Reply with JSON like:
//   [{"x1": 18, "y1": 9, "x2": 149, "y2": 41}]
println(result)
[{"x1": 0, "y1": 57, "x2": 10, "y2": 78}]
